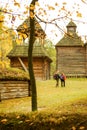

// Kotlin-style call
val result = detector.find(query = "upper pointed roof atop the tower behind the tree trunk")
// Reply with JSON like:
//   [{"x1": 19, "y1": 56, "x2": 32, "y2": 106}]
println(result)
[{"x1": 17, "y1": 18, "x2": 46, "y2": 37}]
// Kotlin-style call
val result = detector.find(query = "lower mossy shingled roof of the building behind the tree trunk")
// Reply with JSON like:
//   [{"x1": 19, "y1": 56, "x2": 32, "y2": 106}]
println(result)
[{"x1": 7, "y1": 43, "x2": 52, "y2": 62}]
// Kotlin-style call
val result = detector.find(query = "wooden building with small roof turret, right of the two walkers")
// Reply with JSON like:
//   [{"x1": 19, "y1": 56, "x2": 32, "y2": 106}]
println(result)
[{"x1": 55, "y1": 21, "x2": 87, "y2": 77}]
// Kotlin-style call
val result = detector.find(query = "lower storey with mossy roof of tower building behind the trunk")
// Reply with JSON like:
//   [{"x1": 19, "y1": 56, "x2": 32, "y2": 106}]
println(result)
[{"x1": 7, "y1": 42, "x2": 52, "y2": 80}]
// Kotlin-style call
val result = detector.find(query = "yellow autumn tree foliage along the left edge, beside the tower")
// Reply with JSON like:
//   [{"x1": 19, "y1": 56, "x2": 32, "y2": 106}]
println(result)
[{"x1": 0, "y1": 9, "x2": 15, "y2": 68}]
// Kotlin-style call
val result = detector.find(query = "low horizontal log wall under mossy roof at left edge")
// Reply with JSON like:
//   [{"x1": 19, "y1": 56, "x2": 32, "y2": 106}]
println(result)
[{"x1": 0, "y1": 81, "x2": 31, "y2": 100}]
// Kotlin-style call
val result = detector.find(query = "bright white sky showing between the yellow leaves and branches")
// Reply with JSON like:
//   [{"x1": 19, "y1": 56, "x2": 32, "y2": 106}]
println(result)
[{"x1": 0, "y1": 0, "x2": 87, "y2": 44}]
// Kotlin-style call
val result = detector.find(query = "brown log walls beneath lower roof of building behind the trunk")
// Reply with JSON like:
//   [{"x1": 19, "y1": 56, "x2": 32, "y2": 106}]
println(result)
[{"x1": 10, "y1": 57, "x2": 50, "y2": 80}]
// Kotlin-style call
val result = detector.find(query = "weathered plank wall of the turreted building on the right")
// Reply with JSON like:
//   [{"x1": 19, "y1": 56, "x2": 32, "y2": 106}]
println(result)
[{"x1": 56, "y1": 46, "x2": 86, "y2": 76}]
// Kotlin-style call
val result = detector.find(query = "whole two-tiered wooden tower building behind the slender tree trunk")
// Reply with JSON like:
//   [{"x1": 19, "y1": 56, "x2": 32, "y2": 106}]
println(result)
[{"x1": 7, "y1": 18, "x2": 52, "y2": 80}]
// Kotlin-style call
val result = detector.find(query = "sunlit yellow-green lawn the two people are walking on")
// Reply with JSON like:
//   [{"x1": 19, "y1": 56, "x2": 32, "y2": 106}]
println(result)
[{"x1": 0, "y1": 78, "x2": 87, "y2": 114}]
